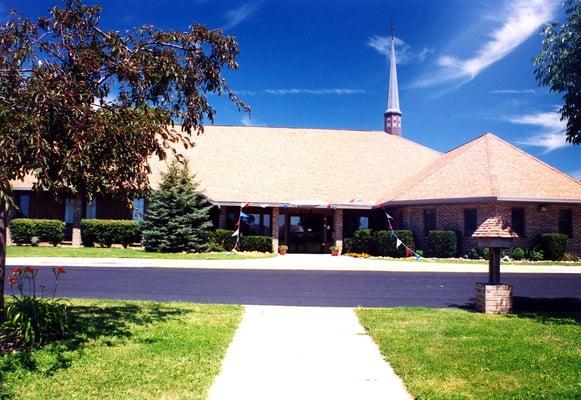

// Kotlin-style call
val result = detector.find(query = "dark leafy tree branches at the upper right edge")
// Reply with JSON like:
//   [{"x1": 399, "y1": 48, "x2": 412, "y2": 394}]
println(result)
[{"x1": 534, "y1": 0, "x2": 581, "y2": 144}]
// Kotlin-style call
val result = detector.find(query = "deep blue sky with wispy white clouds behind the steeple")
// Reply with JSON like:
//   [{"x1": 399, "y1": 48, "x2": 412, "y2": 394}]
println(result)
[{"x1": 0, "y1": 0, "x2": 581, "y2": 178}]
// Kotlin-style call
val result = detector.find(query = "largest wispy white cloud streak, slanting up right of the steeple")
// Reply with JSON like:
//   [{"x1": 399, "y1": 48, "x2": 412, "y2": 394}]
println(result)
[{"x1": 416, "y1": 0, "x2": 559, "y2": 87}]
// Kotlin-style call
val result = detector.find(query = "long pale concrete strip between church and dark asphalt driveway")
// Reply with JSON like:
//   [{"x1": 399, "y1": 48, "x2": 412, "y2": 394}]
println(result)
[{"x1": 6, "y1": 254, "x2": 581, "y2": 274}]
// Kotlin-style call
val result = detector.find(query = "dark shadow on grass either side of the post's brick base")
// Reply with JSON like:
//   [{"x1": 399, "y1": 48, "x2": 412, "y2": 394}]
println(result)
[{"x1": 447, "y1": 296, "x2": 581, "y2": 324}]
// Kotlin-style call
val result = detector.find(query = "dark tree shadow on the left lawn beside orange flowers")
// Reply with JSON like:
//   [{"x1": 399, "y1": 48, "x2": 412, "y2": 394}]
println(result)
[{"x1": 0, "y1": 303, "x2": 189, "y2": 380}]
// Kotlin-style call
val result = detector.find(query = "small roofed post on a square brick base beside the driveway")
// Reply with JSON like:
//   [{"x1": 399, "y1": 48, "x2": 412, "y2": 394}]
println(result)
[{"x1": 472, "y1": 217, "x2": 518, "y2": 314}]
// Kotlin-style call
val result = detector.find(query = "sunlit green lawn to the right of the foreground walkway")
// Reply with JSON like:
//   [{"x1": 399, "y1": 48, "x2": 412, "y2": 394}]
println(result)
[{"x1": 357, "y1": 308, "x2": 581, "y2": 400}]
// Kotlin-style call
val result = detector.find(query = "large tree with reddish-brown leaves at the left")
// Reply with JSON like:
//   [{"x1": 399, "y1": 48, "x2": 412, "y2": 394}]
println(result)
[{"x1": 0, "y1": 0, "x2": 249, "y2": 320}]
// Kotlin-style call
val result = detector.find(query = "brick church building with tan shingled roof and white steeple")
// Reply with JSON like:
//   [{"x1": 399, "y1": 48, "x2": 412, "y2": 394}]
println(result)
[{"x1": 13, "y1": 34, "x2": 581, "y2": 254}]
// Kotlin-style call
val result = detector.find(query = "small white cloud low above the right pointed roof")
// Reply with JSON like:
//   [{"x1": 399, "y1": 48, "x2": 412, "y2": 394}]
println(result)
[{"x1": 507, "y1": 112, "x2": 569, "y2": 153}]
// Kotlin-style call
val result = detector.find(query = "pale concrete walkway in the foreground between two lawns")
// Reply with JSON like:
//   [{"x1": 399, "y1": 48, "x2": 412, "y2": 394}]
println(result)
[{"x1": 209, "y1": 306, "x2": 412, "y2": 400}]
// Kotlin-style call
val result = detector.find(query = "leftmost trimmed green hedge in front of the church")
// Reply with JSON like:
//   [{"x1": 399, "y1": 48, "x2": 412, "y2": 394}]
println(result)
[{"x1": 10, "y1": 218, "x2": 65, "y2": 246}]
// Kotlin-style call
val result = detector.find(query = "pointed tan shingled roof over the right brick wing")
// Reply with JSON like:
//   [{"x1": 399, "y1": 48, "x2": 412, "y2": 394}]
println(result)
[{"x1": 382, "y1": 133, "x2": 581, "y2": 204}]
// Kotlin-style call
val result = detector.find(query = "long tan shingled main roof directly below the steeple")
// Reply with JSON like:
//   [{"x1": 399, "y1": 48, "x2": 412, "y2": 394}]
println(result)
[{"x1": 150, "y1": 126, "x2": 440, "y2": 208}]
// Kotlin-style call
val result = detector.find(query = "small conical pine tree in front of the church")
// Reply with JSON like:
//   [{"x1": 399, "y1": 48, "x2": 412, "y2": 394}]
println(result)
[{"x1": 142, "y1": 161, "x2": 212, "y2": 252}]
